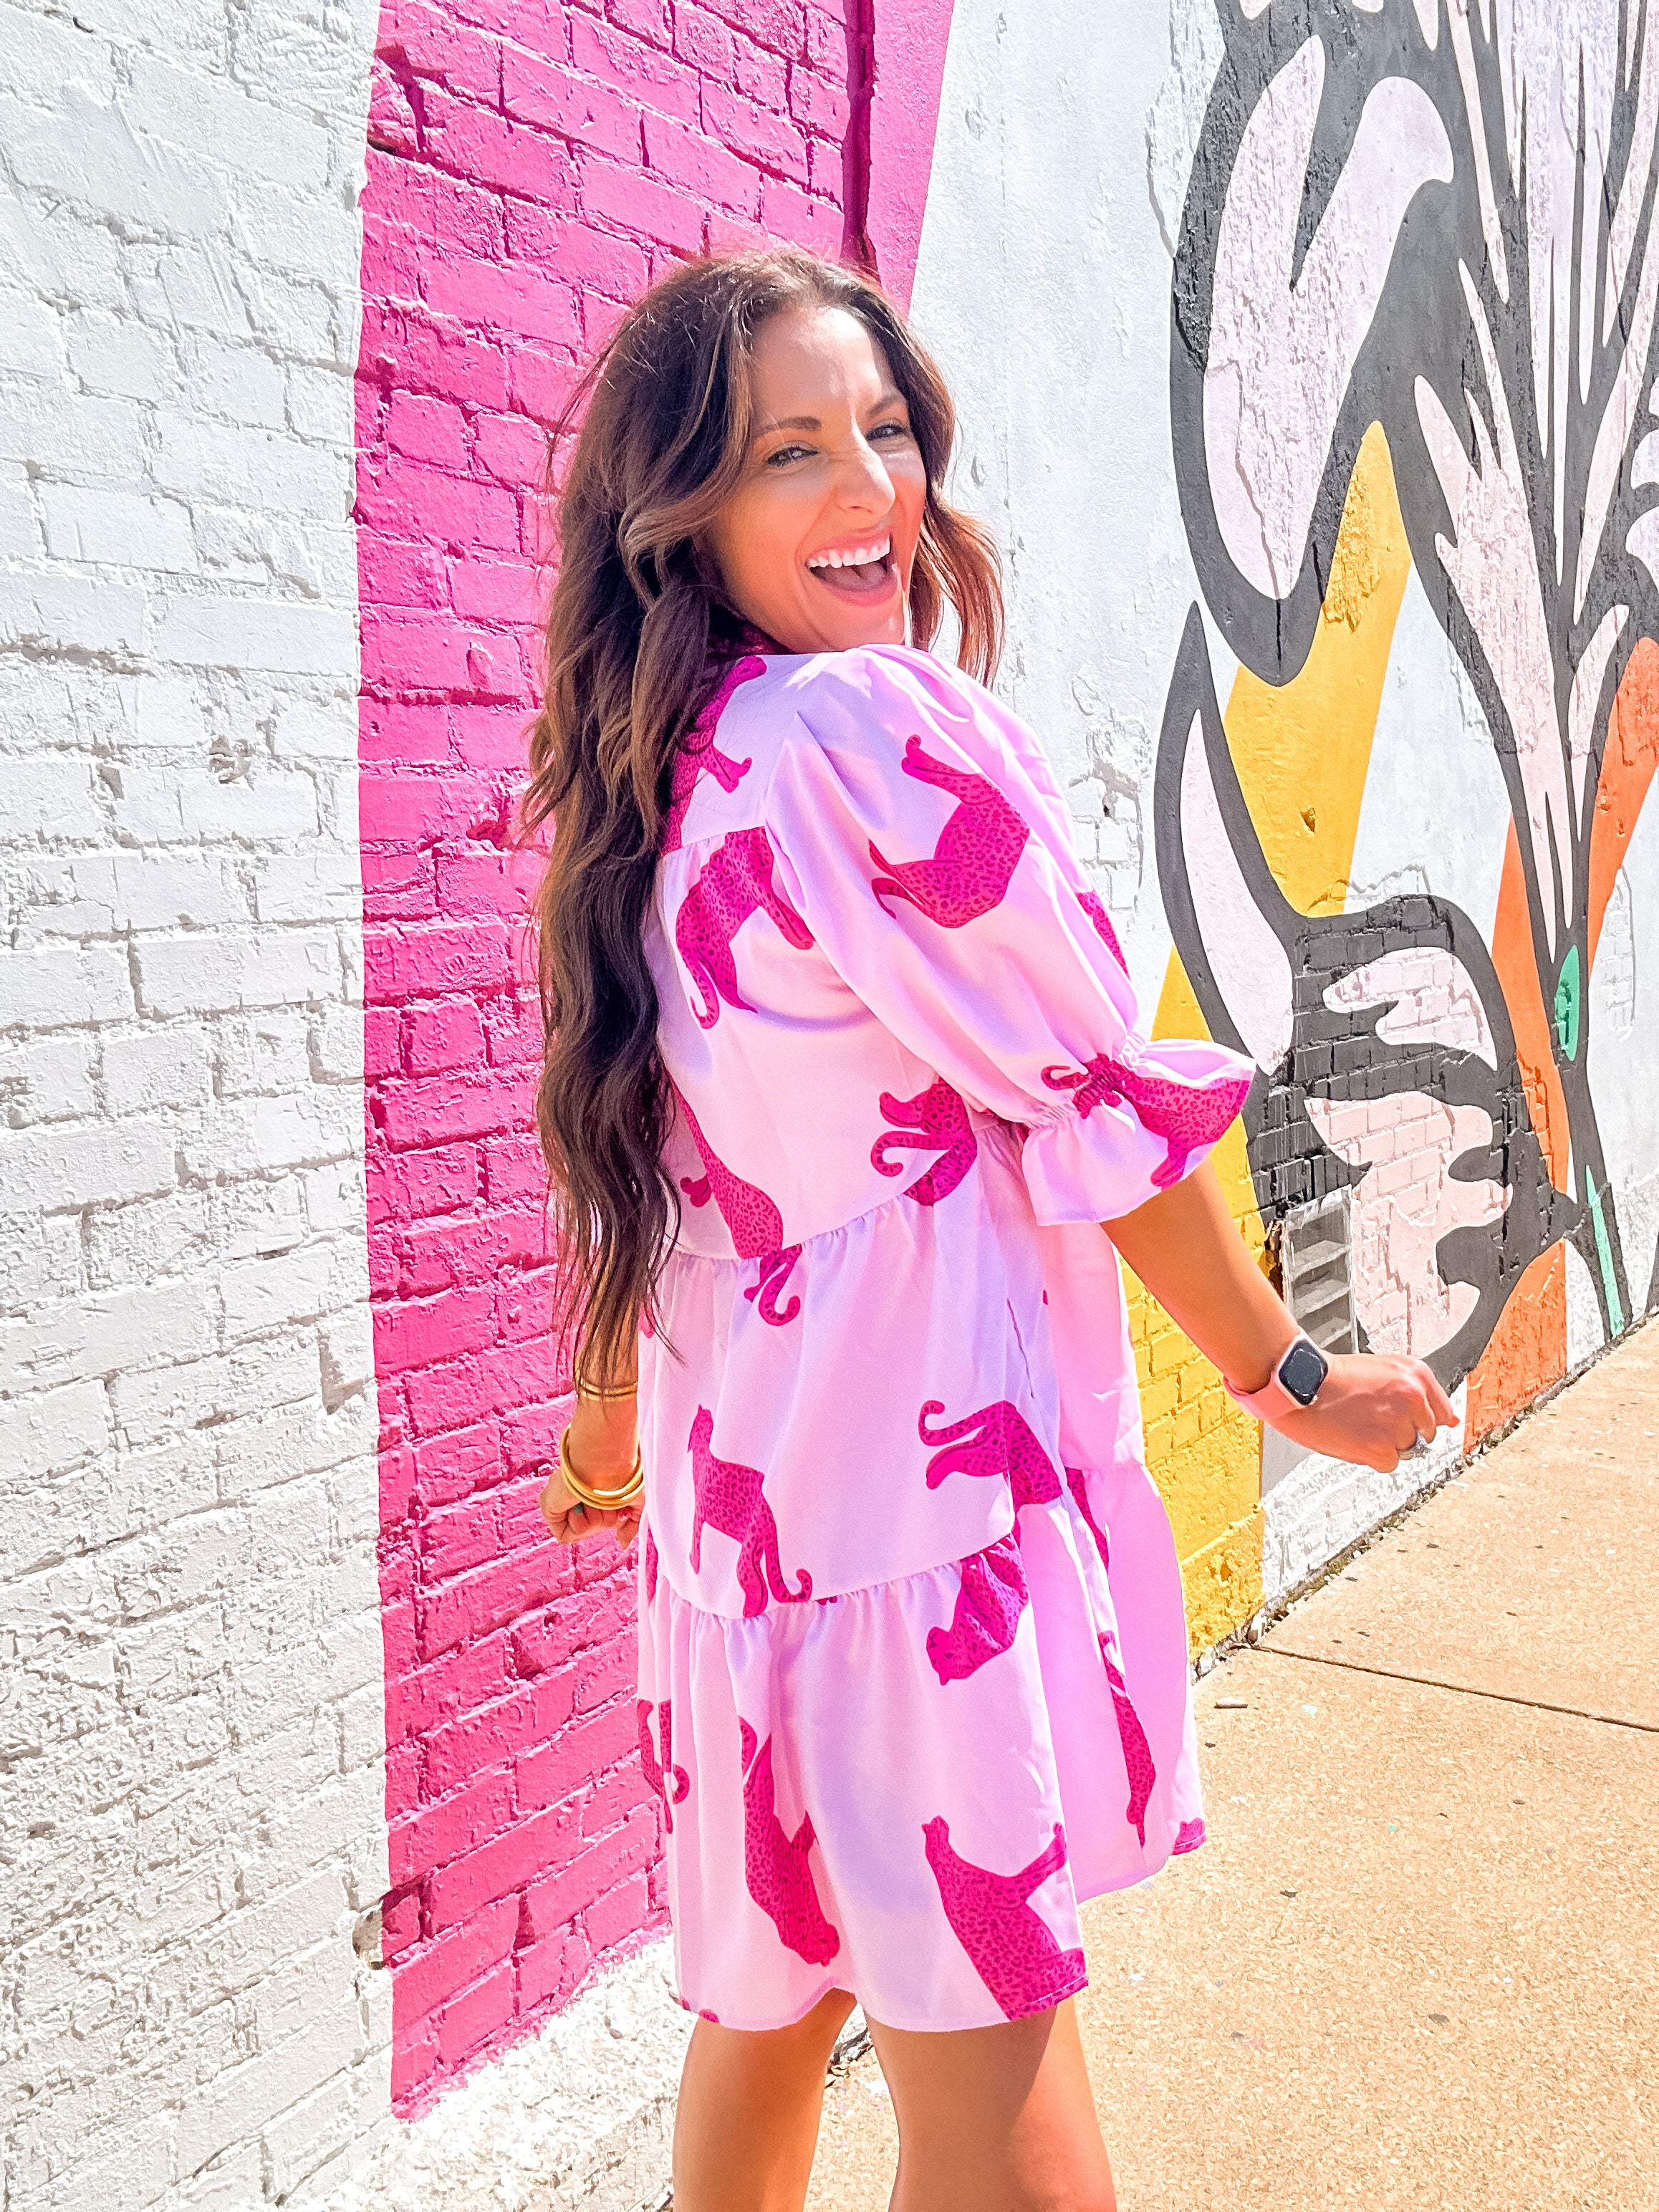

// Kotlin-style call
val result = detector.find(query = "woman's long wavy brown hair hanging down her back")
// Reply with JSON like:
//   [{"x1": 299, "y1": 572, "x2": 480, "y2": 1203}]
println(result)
[{"x1": 524, "y1": 248, "x2": 1002, "y2": 1380}]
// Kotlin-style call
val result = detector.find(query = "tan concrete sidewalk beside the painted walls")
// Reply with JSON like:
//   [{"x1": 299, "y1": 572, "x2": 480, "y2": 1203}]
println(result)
[{"x1": 809, "y1": 1325, "x2": 1659, "y2": 2212}]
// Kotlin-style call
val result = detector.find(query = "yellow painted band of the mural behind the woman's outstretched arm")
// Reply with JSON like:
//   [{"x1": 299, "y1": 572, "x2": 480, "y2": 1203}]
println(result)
[{"x1": 1126, "y1": 423, "x2": 1411, "y2": 1653}]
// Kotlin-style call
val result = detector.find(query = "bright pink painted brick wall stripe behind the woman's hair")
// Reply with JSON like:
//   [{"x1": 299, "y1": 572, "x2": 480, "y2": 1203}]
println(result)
[{"x1": 356, "y1": 0, "x2": 871, "y2": 2110}]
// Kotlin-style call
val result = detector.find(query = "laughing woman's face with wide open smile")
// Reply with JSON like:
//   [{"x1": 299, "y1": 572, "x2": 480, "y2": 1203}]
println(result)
[{"x1": 710, "y1": 307, "x2": 927, "y2": 653}]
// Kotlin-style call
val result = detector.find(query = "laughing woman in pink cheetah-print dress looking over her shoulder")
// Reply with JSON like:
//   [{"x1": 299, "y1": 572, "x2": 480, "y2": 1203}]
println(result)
[{"x1": 531, "y1": 252, "x2": 1453, "y2": 2212}]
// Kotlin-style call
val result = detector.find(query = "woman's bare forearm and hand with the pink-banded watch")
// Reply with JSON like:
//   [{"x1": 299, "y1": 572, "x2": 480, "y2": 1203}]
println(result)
[{"x1": 1102, "y1": 1165, "x2": 1458, "y2": 1473}]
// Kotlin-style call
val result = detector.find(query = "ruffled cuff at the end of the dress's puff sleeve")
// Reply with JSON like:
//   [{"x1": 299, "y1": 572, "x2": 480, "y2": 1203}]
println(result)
[{"x1": 1022, "y1": 1037, "x2": 1254, "y2": 1228}]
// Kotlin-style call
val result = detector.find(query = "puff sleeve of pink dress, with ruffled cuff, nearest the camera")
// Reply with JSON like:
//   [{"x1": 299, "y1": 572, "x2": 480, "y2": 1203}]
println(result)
[{"x1": 768, "y1": 646, "x2": 1252, "y2": 1226}]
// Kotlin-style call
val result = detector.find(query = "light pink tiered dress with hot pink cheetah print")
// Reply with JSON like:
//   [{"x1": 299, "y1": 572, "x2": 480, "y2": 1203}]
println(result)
[{"x1": 639, "y1": 648, "x2": 1248, "y2": 2029}]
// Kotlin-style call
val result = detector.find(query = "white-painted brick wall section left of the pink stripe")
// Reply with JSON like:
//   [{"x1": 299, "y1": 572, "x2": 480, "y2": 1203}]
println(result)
[{"x1": 0, "y1": 0, "x2": 389, "y2": 2212}]
